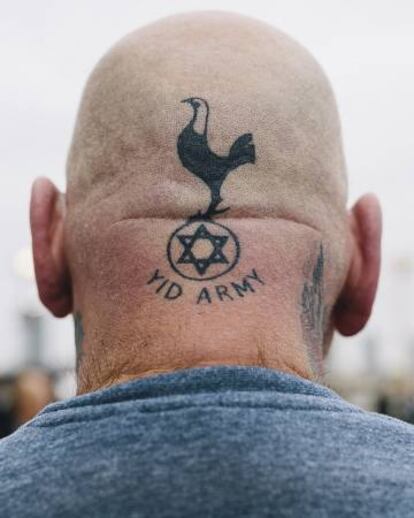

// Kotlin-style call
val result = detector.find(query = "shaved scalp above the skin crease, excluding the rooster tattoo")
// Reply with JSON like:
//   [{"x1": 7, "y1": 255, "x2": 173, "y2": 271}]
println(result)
[{"x1": 68, "y1": 13, "x2": 346, "y2": 233}]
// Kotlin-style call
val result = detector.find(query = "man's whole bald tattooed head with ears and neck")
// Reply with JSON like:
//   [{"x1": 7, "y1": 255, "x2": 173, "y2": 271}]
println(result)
[{"x1": 31, "y1": 13, "x2": 380, "y2": 392}]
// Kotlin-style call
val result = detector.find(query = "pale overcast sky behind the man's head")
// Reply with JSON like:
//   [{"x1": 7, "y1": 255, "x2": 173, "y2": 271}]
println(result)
[{"x1": 0, "y1": 0, "x2": 414, "y2": 376}]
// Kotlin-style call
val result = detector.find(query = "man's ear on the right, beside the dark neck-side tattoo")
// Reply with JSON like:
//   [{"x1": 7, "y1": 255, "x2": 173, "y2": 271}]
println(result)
[{"x1": 333, "y1": 194, "x2": 382, "y2": 336}]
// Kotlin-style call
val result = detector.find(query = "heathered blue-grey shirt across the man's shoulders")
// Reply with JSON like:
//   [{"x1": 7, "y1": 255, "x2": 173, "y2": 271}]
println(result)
[{"x1": 0, "y1": 367, "x2": 414, "y2": 518}]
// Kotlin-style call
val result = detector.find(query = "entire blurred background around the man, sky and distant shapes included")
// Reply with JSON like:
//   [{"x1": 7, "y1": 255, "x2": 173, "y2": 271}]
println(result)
[{"x1": 0, "y1": 0, "x2": 414, "y2": 436}]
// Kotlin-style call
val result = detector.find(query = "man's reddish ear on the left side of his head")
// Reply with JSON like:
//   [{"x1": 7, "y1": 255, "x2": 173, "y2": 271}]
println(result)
[{"x1": 30, "y1": 178, "x2": 72, "y2": 317}]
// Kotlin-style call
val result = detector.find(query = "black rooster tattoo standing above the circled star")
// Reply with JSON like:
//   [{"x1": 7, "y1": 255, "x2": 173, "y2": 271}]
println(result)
[{"x1": 177, "y1": 97, "x2": 256, "y2": 219}]
